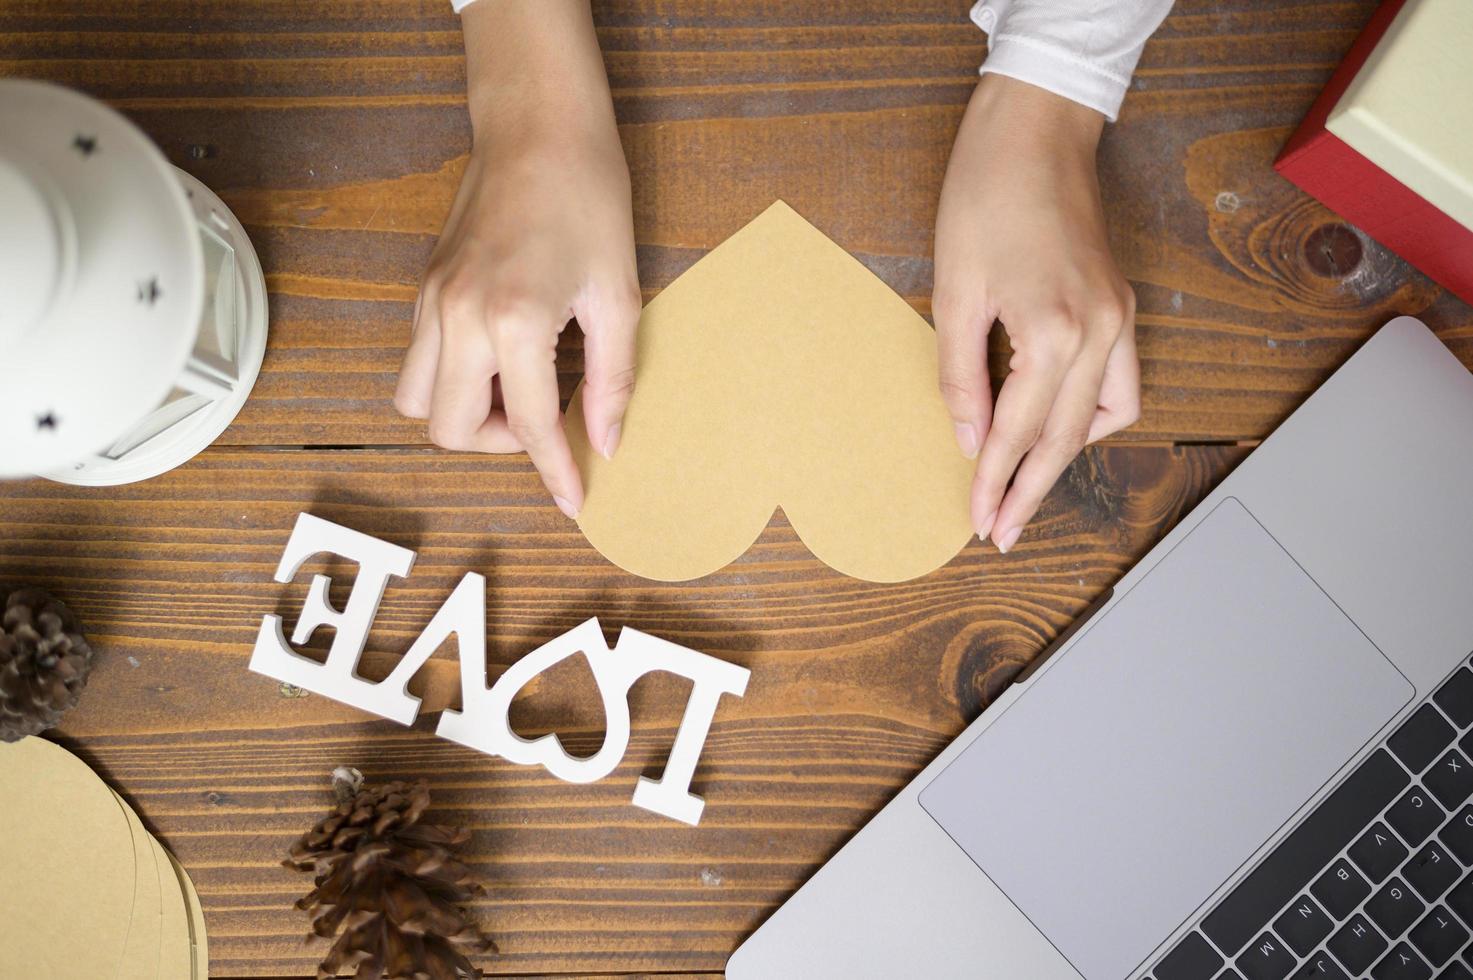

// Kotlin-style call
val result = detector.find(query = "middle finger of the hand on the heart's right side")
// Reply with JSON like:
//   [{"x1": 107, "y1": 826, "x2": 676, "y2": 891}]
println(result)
[{"x1": 993, "y1": 353, "x2": 1105, "y2": 554}]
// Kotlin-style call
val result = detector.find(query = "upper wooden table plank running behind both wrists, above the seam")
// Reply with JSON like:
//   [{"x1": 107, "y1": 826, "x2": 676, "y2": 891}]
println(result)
[{"x1": 0, "y1": 0, "x2": 1473, "y2": 445}]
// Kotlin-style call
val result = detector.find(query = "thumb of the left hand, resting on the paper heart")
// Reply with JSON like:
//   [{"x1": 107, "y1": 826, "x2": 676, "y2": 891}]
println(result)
[{"x1": 574, "y1": 277, "x2": 639, "y2": 458}]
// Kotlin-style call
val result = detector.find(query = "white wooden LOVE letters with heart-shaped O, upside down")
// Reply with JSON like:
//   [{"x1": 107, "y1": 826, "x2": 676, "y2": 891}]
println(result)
[{"x1": 250, "y1": 514, "x2": 750, "y2": 824}]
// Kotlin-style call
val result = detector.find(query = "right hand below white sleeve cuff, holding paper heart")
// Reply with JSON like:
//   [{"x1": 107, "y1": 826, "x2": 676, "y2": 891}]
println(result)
[{"x1": 932, "y1": 74, "x2": 1140, "y2": 553}]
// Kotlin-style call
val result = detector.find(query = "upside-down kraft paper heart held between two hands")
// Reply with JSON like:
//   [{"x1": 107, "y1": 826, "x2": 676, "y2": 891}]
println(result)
[{"x1": 567, "y1": 202, "x2": 975, "y2": 582}]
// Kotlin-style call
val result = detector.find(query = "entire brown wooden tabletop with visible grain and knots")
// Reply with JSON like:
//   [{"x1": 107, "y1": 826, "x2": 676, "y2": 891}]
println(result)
[{"x1": 0, "y1": 0, "x2": 1473, "y2": 977}]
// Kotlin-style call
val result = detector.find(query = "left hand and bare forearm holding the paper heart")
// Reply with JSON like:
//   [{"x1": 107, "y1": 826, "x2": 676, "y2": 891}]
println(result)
[{"x1": 395, "y1": 0, "x2": 641, "y2": 517}]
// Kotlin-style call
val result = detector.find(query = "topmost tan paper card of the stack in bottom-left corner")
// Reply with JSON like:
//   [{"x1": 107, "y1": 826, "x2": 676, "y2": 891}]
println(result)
[{"x1": 0, "y1": 735, "x2": 137, "y2": 980}]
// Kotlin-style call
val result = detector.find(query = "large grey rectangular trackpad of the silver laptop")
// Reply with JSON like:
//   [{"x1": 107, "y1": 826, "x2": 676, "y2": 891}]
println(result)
[{"x1": 921, "y1": 498, "x2": 1414, "y2": 980}]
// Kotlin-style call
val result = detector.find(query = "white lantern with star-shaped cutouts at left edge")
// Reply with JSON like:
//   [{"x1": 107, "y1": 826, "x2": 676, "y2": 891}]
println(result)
[{"x1": 0, "y1": 80, "x2": 267, "y2": 486}]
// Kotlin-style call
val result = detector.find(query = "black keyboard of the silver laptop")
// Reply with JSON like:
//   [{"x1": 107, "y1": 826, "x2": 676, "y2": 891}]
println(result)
[{"x1": 1150, "y1": 666, "x2": 1473, "y2": 980}]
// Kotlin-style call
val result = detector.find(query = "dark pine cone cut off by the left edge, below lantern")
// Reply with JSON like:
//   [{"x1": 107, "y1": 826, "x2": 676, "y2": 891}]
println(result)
[{"x1": 0, "y1": 588, "x2": 93, "y2": 741}]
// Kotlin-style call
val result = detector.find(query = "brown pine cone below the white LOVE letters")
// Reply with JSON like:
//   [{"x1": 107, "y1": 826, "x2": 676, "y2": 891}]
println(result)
[{"x1": 286, "y1": 772, "x2": 496, "y2": 980}]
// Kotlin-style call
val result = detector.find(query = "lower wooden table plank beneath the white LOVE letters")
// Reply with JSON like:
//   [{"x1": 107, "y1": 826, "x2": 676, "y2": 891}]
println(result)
[{"x1": 0, "y1": 447, "x2": 1245, "y2": 976}]
